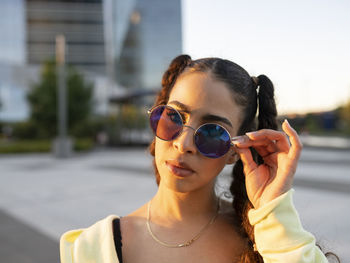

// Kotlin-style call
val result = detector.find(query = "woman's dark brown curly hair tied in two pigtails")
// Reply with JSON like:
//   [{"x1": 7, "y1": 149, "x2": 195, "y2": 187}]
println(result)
[{"x1": 149, "y1": 55, "x2": 340, "y2": 263}]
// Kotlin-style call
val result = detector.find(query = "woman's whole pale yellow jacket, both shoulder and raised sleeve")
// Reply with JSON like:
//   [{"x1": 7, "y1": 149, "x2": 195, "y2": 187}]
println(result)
[{"x1": 60, "y1": 189, "x2": 328, "y2": 263}]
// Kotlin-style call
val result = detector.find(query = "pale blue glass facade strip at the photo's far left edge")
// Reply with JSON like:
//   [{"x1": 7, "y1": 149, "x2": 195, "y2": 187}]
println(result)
[{"x1": 0, "y1": 0, "x2": 28, "y2": 121}]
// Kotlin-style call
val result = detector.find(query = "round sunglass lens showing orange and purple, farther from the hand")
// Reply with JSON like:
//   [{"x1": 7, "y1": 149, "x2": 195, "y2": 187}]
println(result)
[{"x1": 150, "y1": 106, "x2": 182, "y2": 141}]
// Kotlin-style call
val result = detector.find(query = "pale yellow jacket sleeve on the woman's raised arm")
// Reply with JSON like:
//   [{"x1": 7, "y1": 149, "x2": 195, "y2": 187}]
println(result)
[{"x1": 248, "y1": 189, "x2": 328, "y2": 263}]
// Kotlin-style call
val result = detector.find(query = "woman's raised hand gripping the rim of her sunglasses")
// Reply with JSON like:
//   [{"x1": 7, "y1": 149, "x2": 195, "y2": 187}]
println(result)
[{"x1": 232, "y1": 120, "x2": 302, "y2": 208}]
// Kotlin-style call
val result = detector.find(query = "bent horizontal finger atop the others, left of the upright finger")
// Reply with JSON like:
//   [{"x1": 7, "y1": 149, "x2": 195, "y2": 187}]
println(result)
[{"x1": 246, "y1": 129, "x2": 290, "y2": 152}]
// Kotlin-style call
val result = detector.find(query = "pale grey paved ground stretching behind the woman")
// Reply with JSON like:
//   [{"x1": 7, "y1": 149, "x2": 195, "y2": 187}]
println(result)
[{"x1": 0, "y1": 148, "x2": 350, "y2": 263}]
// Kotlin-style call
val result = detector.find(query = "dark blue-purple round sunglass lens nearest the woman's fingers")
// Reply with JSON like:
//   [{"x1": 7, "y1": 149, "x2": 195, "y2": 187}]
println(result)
[{"x1": 194, "y1": 123, "x2": 231, "y2": 158}]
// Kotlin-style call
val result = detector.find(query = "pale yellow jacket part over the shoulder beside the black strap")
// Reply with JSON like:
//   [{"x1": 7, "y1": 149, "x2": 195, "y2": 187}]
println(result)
[{"x1": 60, "y1": 215, "x2": 119, "y2": 263}]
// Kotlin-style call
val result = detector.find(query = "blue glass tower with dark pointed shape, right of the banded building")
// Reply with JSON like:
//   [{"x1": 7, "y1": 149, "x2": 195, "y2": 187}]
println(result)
[{"x1": 104, "y1": 0, "x2": 182, "y2": 97}]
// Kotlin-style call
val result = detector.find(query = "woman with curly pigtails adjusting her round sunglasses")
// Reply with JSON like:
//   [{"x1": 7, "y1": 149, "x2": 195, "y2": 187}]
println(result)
[{"x1": 61, "y1": 55, "x2": 336, "y2": 263}]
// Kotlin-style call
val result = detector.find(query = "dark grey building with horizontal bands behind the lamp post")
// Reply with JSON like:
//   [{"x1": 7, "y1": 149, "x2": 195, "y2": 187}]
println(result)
[{"x1": 26, "y1": 0, "x2": 105, "y2": 74}]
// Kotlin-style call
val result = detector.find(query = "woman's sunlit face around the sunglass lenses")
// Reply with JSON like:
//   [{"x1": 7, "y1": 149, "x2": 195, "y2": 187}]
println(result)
[{"x1": 155, "y1": 73, "x2": 240, "y2": 193}]
